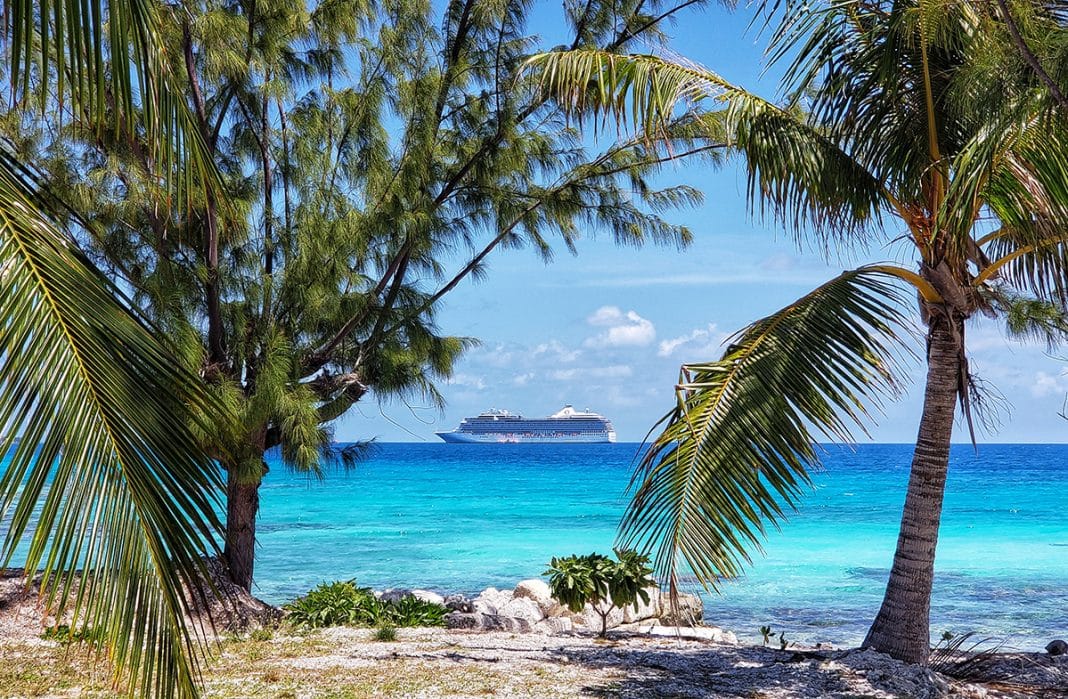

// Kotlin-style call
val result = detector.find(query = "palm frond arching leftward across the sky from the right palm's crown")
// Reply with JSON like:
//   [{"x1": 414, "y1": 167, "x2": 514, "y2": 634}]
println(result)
[{"x1": 528, "y1": 49, "x2": 889, "y2": 243}]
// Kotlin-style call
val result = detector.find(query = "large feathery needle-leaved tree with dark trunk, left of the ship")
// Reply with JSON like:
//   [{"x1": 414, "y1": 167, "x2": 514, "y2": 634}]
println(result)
[{"x1": 5, "y1": 0, "x2": 711, "y2": 590}]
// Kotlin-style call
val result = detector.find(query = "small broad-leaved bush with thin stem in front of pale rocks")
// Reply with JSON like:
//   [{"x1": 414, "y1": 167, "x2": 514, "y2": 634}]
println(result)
[{"x1": 543, "y1": 548, "x2": 657, "y2": 638}]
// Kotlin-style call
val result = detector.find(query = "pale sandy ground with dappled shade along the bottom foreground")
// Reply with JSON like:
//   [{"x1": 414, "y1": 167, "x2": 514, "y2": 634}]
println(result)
[{"x1": 0, "y1": 577, "x2": 1068, "y2": 699}]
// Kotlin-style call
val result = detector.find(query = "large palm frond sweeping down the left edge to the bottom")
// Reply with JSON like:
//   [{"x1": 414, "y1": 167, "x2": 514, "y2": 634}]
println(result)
[{"x1": 0, "y1": 159, "x2": 225, "y2": 697}]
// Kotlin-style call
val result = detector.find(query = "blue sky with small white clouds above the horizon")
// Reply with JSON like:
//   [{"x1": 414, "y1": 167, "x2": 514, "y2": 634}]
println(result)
[{"x1": 335, "y1": 3, "x2": 1068, "y2": 442}]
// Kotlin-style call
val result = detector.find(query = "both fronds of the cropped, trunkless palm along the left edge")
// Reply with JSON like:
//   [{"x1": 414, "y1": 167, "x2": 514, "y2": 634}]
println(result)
[{"x1": 0, "y1": 0, "x2": 227, "y2": 697}]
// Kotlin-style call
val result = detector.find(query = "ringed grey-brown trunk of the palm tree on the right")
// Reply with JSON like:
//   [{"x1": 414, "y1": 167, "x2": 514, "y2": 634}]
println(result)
[{"x1": 862, "y1": 312, "x2": 963, "y2": 664}]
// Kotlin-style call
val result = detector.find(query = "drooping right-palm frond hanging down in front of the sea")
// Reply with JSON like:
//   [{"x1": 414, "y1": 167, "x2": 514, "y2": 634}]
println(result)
[{"x1": 621, "y1": 268, "x2": 909, "y2": 589}]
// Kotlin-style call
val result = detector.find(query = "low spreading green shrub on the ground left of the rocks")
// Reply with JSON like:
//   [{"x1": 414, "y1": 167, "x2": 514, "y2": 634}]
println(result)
[{"x1": 283, "y1": 580, "x2": 449, "y2": 628}]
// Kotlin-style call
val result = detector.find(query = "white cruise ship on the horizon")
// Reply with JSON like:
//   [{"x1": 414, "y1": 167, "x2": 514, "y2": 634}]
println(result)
[{"x1": 435, "y1": 405, "x2": 615, "y2": 444}]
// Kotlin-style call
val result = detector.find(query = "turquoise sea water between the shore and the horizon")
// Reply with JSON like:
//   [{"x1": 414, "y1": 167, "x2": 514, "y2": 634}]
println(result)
[{"x1": 255, "y1": 444, "x2": 1068, "y2": 649}]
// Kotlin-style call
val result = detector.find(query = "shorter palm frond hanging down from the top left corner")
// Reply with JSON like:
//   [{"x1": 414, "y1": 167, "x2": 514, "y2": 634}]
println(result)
[{"x1": 2, "y1": 0, "x2": 218, "y2": 206}]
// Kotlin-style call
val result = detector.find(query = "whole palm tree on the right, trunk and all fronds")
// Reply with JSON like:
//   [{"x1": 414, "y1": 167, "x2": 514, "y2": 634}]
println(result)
[{"x1": 531, "y1": 0, "x2": 1068, "y2": 663}]
